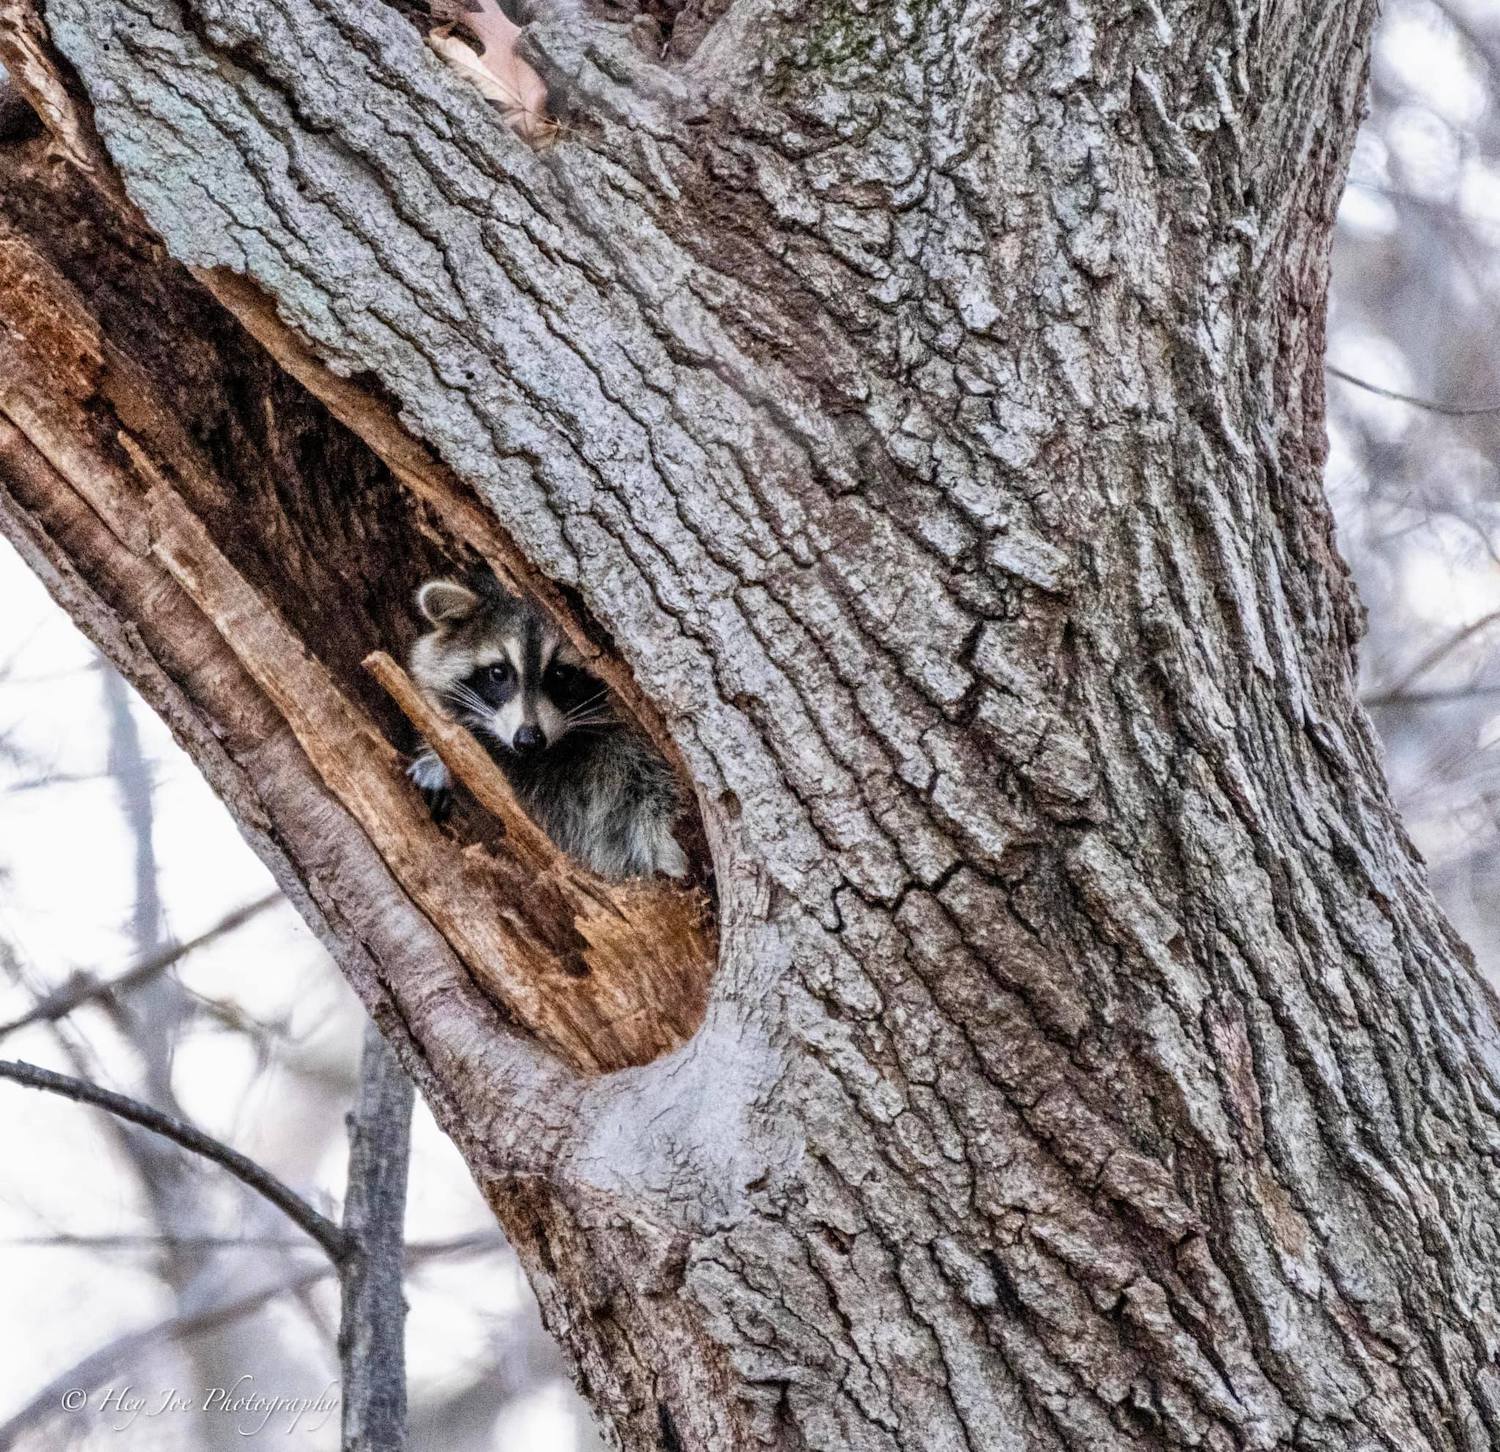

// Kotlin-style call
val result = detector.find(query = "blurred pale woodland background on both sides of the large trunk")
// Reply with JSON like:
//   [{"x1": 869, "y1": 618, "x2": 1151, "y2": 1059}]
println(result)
[{"x1": 0, "y1": 0, "x2": 1500, "y2": 1452}]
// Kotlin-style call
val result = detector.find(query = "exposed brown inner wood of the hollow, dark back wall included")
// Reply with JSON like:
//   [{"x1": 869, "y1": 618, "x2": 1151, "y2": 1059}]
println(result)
[{"x1": 0, "y1": 127, "x2": 713, "y2": 1073}]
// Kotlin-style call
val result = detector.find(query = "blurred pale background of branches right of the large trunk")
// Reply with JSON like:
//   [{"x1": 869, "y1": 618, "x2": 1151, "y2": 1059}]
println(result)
[{"x1": 1326, "y1": 0, "x2": 1500, "y2": 984}]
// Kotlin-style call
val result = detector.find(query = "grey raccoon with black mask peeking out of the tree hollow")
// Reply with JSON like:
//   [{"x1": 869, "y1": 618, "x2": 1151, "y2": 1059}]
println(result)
[{"x1": 408, "y1": 576, "x2": 687, "y2": 881}]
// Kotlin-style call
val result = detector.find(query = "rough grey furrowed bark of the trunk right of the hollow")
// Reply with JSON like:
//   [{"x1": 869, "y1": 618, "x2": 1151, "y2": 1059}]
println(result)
[{"x1": 5, "y1": 0, "x2": 1500, "y2": 1452}]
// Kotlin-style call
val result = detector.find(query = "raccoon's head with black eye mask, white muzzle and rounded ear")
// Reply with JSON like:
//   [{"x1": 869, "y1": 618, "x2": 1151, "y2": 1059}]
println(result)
[{"x1": 411, "y1": 579, "x2": 615, "y2": 756}]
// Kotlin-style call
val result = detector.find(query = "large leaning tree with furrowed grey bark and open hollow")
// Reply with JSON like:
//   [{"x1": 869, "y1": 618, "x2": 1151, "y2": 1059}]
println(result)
[{"x1": 0, "y1": 0, "x2": 1500, "y2": 1452}]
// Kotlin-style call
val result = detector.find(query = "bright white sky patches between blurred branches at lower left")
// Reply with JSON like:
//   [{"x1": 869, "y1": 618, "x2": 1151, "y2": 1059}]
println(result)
[{"x1": 0, "y1": 542, "x2": 581, "y2": 1452}]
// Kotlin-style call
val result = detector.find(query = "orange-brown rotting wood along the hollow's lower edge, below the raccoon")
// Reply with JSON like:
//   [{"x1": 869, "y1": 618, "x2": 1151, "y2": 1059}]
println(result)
[{"x1": 0, "y1": 204, "x2": 713, "y2": 1073}]
